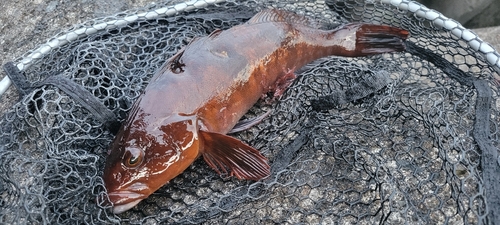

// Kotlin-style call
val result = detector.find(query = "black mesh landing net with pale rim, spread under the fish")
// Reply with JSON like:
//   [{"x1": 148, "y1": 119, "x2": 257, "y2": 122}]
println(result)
[{"x1": 0, "y1": 0, "x2": 500, "y2": 224}]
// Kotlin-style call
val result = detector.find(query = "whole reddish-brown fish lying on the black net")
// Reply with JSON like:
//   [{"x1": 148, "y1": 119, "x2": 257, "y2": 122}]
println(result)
[{"x1": 103, "y1": 9, "x2": 409, "y2": 214}]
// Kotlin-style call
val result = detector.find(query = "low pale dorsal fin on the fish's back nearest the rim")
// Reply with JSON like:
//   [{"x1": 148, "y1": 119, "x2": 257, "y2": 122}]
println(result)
[{"x1": 247, "y1": 9, "x2": 319, "y2": 27}]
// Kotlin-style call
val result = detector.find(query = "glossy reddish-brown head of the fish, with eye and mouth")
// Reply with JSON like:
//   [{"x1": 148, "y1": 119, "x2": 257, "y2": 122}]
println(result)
[{"x1": 103, "y1": 116, "x2": 201, "y2": 214}]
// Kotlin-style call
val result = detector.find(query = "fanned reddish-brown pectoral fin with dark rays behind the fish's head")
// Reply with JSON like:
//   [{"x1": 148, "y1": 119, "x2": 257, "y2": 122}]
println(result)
[{"x1": 200, "y1": 131, "x2": 271, "y2": 181}]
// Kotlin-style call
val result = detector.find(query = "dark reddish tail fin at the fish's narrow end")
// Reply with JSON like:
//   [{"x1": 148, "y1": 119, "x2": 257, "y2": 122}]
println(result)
[{"x1": 348, "y1": 24, "x2": 409, "y2": 56}]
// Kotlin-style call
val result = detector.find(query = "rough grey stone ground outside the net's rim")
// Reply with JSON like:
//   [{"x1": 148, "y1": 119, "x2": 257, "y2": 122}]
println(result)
[{"x1": 0, "y1": 0, "x2": 500, "y2": 118}]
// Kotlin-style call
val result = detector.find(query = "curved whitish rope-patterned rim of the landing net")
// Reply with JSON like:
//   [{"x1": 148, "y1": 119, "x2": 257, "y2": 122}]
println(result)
[{"x1": 0, "y1": 0, "x2": 500, "y2": 98}]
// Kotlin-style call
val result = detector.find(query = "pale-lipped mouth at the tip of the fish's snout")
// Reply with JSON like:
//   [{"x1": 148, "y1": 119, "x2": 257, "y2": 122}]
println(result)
[{"x1": 108, "y1": 191, "x2": 147, "y2": 214}]
